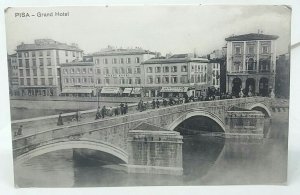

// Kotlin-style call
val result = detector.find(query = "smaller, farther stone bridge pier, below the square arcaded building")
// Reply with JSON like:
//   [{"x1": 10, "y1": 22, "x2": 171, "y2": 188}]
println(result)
[{"x1": 225, "y1": 109, "x2": 265, "y2": 139}]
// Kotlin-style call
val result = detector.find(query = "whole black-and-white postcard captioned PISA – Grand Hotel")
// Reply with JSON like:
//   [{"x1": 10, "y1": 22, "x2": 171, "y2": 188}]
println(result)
[{"x1": 5, "y1": 5, "x2": 292, "y2": 188}]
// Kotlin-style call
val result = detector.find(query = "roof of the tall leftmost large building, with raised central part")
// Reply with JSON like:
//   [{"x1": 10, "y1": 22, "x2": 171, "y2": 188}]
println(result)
[{"x1": 17, "y1": 39, "x2": 83, "y2": 51}]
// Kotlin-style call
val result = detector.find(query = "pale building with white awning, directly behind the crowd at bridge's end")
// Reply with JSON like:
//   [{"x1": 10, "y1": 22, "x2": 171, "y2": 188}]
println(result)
[{"x1": 142, "y1": 54, "x2": 213, "y2": 97}]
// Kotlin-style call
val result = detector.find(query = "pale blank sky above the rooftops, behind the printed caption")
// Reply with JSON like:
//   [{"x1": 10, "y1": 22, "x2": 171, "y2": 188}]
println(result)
[{"x1": 5, "y1": 5, "x2": 291, "y2": 55}]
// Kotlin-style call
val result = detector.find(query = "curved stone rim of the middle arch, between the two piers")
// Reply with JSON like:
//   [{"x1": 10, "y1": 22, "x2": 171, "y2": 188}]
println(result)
[{"x1": 167, "y1": 110, "x2": 226, "y2": 133}]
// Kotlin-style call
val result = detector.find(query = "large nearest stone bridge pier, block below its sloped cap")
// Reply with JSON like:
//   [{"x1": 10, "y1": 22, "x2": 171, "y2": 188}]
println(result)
[{"x1": 127, "y1": 130, "x2": 183, "y2": 175}]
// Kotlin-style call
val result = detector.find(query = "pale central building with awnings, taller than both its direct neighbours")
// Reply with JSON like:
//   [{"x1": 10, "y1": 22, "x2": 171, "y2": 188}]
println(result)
[{"x1": 93, "y1": 47, "x2": 156, "y2": 96}]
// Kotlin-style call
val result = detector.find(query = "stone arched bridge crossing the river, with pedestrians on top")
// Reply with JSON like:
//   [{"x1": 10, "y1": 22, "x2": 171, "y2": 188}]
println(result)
[{"x1": 12, "y1": 97, "x2": 272, "y2": 174}]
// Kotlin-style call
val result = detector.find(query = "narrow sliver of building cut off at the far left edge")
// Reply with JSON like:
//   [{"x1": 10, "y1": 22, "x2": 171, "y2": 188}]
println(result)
[{"x1": 7, "y1": 54, "x2": 19, "y2": 95}]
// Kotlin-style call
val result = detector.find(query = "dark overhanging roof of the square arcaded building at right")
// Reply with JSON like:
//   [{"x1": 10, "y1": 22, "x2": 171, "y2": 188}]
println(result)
[{"x1": 225, "y1": 33, "x2": 279, "y2": 41}]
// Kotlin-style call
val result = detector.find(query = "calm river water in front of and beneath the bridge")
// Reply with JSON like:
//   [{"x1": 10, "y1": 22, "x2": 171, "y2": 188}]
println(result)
[{"x1": 15, "y1": 113, "x2": 288, "y2": 187}]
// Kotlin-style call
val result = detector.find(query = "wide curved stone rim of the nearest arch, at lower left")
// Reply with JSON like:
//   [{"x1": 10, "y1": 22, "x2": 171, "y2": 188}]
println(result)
[{"x1": 15, "y1": 140, "x2": 128, "y2": 164}]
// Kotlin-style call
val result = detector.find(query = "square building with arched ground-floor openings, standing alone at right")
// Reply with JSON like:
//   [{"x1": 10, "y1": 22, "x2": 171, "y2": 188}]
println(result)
[{"x1": 225, "y1": 33, "x2": 278, "y2": 96}]
